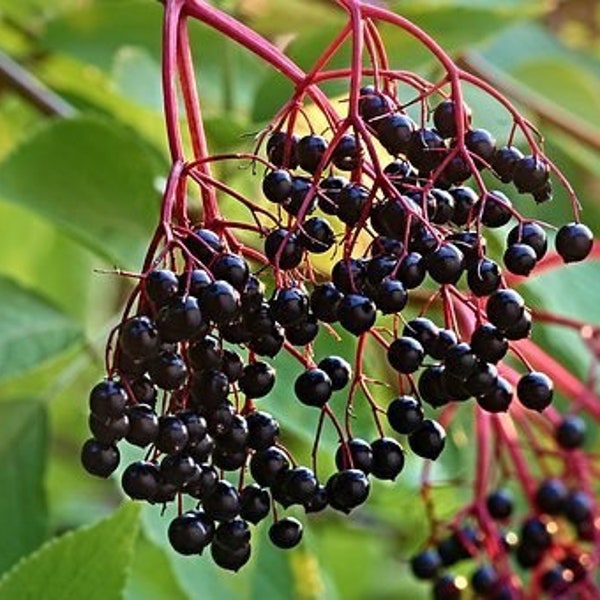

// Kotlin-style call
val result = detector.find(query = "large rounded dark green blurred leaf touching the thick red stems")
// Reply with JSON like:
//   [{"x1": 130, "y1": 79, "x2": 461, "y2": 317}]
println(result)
[{"x1": 0, "y1": 117, "x2": 164, "y2": 268}]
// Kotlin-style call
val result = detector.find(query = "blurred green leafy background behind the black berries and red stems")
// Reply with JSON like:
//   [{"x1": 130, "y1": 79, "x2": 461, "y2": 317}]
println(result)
[{"x1": 0, "y1": 0, "x2": 600, "y2": 600}]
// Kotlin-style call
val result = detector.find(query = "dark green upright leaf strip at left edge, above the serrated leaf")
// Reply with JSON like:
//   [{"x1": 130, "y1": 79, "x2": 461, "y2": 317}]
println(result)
[{"x1": 0, "y1": 398, "x2": 48, "y2": 572}]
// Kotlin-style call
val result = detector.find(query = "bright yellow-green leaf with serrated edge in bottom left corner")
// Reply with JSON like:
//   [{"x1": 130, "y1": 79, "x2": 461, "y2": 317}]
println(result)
[{"x1": 0, "y1": 503, "x2": 139, "y2": 600}]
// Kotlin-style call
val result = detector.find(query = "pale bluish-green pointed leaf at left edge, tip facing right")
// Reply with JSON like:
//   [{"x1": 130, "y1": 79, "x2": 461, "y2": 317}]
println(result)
[{"x1": 0, "y1": 276, "x2": 81, "y2": 380}]
